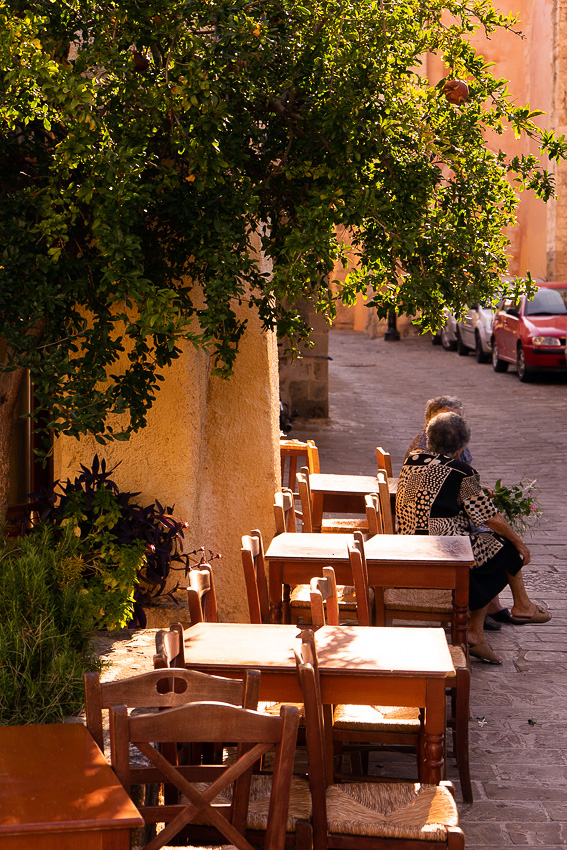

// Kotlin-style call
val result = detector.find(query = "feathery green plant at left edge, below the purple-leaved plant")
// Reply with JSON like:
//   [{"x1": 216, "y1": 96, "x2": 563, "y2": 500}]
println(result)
[{"x1": 0, "y1": 528, "x2": 100, "y2": 725}]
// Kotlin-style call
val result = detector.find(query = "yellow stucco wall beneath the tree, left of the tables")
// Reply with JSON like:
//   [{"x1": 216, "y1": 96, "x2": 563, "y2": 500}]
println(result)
[{"x1": 54, "y1": 298, "x2": 279, "y2": 622}]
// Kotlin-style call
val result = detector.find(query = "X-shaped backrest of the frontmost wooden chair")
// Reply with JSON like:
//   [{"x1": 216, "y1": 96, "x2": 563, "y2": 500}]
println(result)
[{"x1": 110, "y1": 702, "x2": 299, "y2": 850}]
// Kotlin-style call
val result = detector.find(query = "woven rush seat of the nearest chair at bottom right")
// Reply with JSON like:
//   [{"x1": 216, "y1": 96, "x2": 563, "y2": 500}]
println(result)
[{"x1": 326, "y1": 782, "x2": 459, "y2": 841}]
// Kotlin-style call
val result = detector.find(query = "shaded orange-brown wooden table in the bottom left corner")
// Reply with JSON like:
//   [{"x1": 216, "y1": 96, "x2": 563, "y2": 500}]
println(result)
[{"x1": 0, "y1": 723, "x2": 144, "y2": 850}]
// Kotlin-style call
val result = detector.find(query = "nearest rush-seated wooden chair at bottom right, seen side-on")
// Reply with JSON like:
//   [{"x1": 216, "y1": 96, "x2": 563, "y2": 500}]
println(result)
[{"x1": 296, "y1": 632, "x2": 465, "y2": 850}]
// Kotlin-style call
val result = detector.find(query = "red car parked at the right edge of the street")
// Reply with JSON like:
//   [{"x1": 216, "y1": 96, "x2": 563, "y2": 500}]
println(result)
[{"x1": 492, "y1": 281, "x2": 567, "y2": 381}]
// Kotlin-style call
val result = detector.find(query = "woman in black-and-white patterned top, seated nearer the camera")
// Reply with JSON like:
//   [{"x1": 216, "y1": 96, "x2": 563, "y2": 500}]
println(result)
[{"x1": 396, "y1": 413, "x2": 551, "y2": 664}]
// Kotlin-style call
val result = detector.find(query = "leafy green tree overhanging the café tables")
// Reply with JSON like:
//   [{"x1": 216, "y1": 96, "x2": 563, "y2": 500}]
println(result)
[{"x1": 0, "y1": 0, "x2": 566, "y2": 512}]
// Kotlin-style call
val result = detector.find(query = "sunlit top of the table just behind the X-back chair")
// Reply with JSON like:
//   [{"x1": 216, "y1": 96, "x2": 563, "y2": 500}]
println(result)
[{"x1": 185, "y1": 623, "x2": 454, "y2": 678}]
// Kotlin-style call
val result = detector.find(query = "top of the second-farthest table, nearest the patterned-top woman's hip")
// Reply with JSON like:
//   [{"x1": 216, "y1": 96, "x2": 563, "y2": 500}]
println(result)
[{"x1": 266, "y1": 532, "x2": 474, "y2": 567}]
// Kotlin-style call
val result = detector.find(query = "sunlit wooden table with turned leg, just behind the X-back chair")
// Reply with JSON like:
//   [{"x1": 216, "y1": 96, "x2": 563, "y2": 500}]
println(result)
[{"x1": 185, "y1": 623, "x2": 454, "y2": 784}]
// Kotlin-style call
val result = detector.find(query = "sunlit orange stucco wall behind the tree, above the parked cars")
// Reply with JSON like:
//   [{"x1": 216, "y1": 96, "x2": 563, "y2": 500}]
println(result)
[{"x1": 334, "y1": 0, "x2": 567, "y2": 335}]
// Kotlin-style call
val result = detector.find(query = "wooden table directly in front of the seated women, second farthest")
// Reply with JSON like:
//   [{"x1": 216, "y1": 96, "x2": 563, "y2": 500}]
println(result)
[{"x1": 266, "y1": 532, "x2": 474, "y2": 645}]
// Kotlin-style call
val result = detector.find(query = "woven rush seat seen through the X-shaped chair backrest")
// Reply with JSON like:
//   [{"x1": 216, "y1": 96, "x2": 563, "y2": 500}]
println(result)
[{"x1": 189, "y1": 772, "x2": 312, "y2": 832}]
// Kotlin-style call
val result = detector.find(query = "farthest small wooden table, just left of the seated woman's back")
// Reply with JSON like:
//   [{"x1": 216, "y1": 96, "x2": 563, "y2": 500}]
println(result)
[{"x1": 309, "y1": 472, "x2": 398, "y2": 531}]
